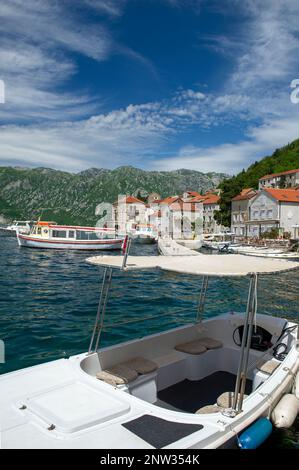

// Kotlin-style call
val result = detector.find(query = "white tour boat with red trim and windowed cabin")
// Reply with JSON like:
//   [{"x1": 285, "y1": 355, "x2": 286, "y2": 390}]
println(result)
[{"x1": 17, "y1": 221, "x2": 124, "y2": 250}]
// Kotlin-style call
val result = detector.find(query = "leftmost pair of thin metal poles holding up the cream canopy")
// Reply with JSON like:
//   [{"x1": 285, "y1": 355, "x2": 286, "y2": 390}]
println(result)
[{"x1": 88, "y1": 268, "x2": 112, "y2": 354}]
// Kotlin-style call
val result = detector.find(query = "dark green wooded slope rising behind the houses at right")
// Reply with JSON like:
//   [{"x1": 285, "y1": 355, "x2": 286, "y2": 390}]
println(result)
[{"x1": 216, "y1": 139, "x2": 299, "y2": 227}]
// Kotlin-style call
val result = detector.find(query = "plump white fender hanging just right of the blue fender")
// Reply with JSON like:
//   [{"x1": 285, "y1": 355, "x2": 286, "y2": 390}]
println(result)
[{"x1": 271, "y1": 393, "x2": 299, "y2": 428}]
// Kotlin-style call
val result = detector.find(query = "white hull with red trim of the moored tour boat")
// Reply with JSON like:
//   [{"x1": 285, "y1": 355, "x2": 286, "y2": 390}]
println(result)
[{"x1": 18, "y1": 234, "x2": 123, "y2": 251}]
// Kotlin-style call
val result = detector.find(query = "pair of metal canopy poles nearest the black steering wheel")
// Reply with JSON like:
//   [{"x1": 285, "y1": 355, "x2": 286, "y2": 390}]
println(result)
[{"x1": 231, "y1": 274, "x2": 257, "y2": 416}]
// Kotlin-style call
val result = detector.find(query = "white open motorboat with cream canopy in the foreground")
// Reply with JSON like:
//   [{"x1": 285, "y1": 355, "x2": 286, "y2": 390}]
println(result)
[{"x1": 0, "y1": 252, "x2": 299, "y2": 449}]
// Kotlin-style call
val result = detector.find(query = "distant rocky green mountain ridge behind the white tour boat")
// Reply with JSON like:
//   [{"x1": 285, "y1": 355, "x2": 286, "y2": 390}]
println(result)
[{"x1": 0, "y1": 167, "x2": 227, "y2": 224}]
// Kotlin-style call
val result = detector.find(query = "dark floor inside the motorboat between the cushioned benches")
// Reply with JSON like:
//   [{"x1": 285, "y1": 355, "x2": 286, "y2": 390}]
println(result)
[{"x1": 155, "y1": 371, "x2": 252, "y2": 413}]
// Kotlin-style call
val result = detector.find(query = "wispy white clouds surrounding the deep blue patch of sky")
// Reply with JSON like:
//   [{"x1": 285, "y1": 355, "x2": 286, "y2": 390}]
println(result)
[{"x1": 0, "y1": 0, "x2": 299, "y2": 173}]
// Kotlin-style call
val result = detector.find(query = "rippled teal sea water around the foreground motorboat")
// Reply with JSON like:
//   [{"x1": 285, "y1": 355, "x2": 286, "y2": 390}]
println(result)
[{"x1": 0, "y1": 237, "x2": 299, "y2": 446}]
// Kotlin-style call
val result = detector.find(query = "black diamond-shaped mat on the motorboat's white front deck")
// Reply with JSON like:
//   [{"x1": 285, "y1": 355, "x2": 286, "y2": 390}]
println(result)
[{"x1": 122, "y1": 415, "x2": 203, "y2": 449}]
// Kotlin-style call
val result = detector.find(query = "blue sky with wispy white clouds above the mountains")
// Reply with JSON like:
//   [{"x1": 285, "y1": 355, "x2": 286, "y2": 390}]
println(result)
[{"x1": 0, "y1": 0, "x2": 299, "y2": 174}]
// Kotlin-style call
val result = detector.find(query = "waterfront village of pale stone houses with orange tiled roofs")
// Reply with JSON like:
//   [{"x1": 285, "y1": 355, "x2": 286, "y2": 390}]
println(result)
[{"x1": 114, "y1": 169, "x2": 299, "y2": 239}]
